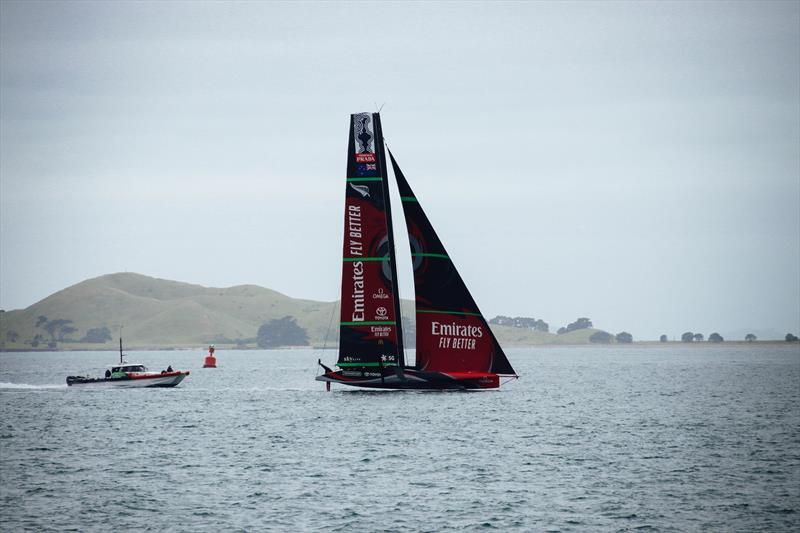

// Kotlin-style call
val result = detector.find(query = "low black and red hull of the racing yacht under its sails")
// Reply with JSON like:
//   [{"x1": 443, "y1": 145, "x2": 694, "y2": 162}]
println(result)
[{"x1": 317, "y1": 368, "x2": 500, "y2": 390}]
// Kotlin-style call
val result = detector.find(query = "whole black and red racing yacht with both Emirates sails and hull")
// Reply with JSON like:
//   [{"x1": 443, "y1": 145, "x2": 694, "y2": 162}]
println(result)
[{"x1": 316, "y1": 113, "x2": 517, "y2": 389}]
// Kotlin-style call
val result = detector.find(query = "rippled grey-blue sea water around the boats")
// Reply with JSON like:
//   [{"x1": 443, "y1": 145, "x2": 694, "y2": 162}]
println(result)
[{"x1": 0, "y1": 345, "x2": 800, "y2": 532}]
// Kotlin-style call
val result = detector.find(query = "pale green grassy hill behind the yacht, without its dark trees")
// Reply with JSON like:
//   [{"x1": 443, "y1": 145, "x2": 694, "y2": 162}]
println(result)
[{"x1": 0, "y1": 273, "x2": 608, "y2": 350}]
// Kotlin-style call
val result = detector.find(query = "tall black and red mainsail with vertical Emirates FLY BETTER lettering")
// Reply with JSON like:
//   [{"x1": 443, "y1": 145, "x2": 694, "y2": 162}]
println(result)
[{"x1": 337, "y1": 113, "x2": 403, "y2": 369}]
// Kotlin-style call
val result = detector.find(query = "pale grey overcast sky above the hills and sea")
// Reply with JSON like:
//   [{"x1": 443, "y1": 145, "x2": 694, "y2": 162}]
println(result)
[{"x1": 0, "y1": 1, "x2": 800, "y2": 338}]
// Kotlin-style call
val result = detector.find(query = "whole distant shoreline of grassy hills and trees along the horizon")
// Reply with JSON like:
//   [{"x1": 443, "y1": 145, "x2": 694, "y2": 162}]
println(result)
[{"x1": 0, "y1": 273, "x2": 785, "y2": 352}]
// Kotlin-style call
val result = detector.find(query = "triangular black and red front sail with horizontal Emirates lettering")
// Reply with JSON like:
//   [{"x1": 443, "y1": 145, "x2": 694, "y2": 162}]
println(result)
[{"x1": 389, "y1": 152, "x2": 516, "y2": 375}]
